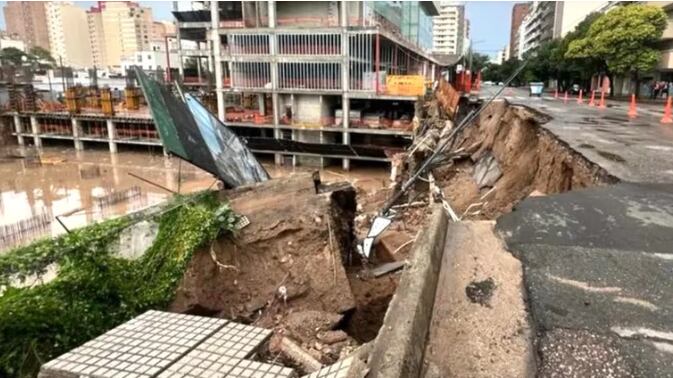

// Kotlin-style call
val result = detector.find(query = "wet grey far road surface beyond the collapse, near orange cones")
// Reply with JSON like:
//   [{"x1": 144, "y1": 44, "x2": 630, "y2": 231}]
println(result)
[{"x1": 481, "y1": 87, "x2": 673, "y2": 183}]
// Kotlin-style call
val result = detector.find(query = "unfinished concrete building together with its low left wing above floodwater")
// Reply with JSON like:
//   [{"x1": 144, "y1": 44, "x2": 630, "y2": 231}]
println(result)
[{"x1": 3, "y1": 1, "x2": 454, "y2": 169}]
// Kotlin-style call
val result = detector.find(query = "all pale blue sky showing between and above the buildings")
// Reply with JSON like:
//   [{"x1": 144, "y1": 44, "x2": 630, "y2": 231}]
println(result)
[{"x1": 0, "y1": 1, "x2": 515, "y2": 56}]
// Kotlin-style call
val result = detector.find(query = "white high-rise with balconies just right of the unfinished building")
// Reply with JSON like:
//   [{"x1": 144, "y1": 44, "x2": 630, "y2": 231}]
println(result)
[{"x1": 432, "y1": 1, "x2": 468, "y2": 55}]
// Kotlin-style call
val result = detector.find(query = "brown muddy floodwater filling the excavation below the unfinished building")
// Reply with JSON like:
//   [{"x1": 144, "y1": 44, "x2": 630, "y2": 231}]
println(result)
[{"x1": 0, "y1": 147, "x2": 388, "y2": 252}]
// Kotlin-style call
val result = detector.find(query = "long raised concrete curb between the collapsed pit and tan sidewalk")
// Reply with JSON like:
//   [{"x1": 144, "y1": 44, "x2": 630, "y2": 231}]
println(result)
[{"x1": 362, "y1": 205, "x2": 448, "y2": 378}]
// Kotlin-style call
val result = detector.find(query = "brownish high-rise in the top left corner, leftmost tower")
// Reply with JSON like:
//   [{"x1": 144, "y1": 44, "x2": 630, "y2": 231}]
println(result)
[{"x1": 3, "y1": 1, "x2": 49, "y2": 50}]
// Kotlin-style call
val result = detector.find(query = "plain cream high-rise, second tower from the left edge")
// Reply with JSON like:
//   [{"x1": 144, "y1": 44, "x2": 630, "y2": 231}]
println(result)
[{"x1": 46, "y1": 1, "x2": 93, "y2": 68}]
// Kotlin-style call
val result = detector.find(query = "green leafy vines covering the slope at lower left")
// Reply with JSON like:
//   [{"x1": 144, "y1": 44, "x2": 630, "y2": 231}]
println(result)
[{"x1": 0, "y1": 193, "x2": 238, "y2": 377}]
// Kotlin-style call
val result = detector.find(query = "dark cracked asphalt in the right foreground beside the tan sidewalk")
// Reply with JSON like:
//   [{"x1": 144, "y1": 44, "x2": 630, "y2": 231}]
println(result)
[{"x1": 497, "y1": 183, "x2": 673, "y2": 377}]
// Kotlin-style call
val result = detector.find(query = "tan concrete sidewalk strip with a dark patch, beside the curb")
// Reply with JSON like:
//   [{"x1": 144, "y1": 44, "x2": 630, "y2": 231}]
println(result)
[{"x1": 424, "y1": 221, "x2": 535, "y2": 377}]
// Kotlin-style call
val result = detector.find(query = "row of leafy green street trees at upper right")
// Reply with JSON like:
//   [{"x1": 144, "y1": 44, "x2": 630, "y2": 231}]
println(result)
[{"x1": 482, "y1": 4, "x2": 667, "y2": 91}]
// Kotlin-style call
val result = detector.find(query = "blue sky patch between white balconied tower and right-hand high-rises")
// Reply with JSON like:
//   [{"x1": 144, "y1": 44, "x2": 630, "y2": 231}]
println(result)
[{"x1": 465, "y1": 1, "x2": 516, "y2": 57}]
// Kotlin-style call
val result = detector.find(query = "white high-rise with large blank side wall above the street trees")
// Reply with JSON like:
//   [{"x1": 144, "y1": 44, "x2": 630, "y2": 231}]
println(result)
[{"x1": 519, "y1": 1, "x2": 608, "y2": 55}]
